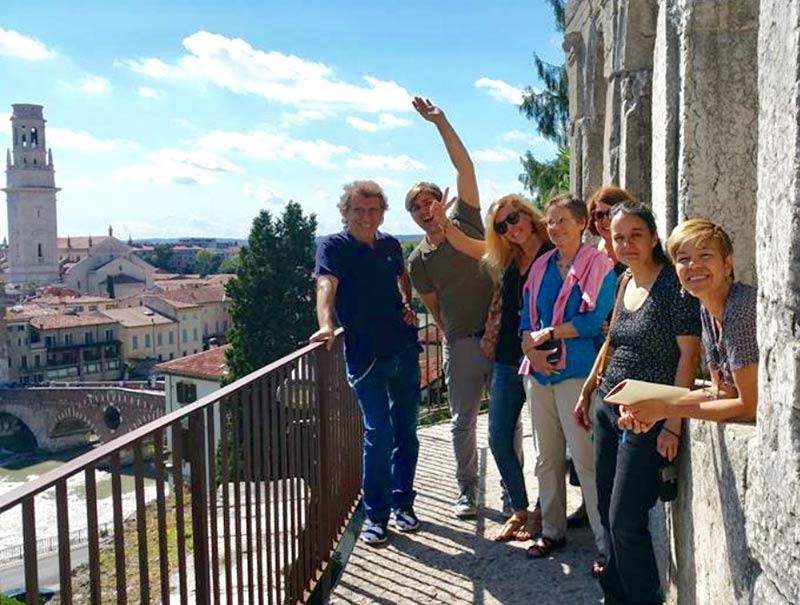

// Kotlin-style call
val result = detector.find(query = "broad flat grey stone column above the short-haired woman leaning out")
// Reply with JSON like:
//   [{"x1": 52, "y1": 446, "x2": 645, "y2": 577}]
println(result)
[{"x1": 677, "y1": 0, "x2": 759, "y2": 283}]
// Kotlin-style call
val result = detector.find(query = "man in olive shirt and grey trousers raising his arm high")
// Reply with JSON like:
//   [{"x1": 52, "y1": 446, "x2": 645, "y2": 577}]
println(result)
[{"x1": 406, "y1": 97, "x2": 493, "y2": 517}]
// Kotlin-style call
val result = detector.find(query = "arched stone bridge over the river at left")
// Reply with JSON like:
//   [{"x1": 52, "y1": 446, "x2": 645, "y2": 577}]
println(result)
[{"x1": 0, "y1": 387, "x2": 164, "y2": 451}]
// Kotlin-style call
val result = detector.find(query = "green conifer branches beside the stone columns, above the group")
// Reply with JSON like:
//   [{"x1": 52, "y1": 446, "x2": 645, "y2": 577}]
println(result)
[{"x1": 519, "y1": 0, "x2": 569, "y2": 204}]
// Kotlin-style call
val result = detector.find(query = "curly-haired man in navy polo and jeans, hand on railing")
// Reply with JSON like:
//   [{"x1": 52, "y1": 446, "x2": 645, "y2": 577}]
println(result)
[{"x1": 311, "y1": 181, "x2": 420, "y2": 544}]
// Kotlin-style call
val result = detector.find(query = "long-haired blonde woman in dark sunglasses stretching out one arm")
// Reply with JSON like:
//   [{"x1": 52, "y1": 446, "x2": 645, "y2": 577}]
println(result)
[{"x1": 432, "y1": 194, "x2": 553, "y2": 541}]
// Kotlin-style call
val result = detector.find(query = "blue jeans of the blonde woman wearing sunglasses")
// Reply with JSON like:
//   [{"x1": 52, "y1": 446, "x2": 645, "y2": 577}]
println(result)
[{"x1": 489, "y1": 362, "x2": 529, "y2": 511}]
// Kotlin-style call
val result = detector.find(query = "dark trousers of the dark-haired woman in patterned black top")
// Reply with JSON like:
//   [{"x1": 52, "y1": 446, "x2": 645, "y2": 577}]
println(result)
[{"x1": 594, "y1": 395, "x2": 664, "y2": 605}]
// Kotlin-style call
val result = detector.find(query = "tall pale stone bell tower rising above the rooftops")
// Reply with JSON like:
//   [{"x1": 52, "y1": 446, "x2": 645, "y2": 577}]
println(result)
[{"x1": 3, "y1": 104, "x2": 60, "y2": 284}]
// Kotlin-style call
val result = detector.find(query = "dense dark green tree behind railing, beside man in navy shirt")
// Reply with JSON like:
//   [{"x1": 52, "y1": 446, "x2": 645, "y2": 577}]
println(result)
[{"x1": 226, "y1": 201, "x2": 317, "y2": 380}]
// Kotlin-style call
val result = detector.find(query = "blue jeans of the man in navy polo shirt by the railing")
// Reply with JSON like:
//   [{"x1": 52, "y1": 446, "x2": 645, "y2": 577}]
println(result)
[{"x1": 347, "y1": 345, "x2": 420, "y2": 522}]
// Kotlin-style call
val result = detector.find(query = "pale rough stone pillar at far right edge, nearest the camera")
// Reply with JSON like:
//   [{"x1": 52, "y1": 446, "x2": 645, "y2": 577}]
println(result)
[{"x1": 747, "y1": 0, "x2": 800, "y2": 605}]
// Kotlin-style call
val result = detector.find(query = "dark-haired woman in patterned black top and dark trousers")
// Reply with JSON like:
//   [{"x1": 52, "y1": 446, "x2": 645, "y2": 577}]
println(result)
[{"x1": 575, "y1": 201, "x2": 700, "y2": 603}]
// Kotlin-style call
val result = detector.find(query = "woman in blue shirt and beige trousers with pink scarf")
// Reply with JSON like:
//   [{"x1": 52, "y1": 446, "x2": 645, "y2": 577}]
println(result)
[{"x1": 520, "y1": 194, "x2": 617, "y2": 558}]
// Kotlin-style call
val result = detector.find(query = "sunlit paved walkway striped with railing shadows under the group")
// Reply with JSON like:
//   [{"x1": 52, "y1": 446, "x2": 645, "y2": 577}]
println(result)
[{"x1": 329, "y1": 408, "x2": 602, "y2": 605}]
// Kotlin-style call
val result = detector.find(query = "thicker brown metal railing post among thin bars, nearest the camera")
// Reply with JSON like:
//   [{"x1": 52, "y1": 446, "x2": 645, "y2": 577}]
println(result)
[{"x1": 186, "y1": 412, "x2": 211, "y2": 605}]
